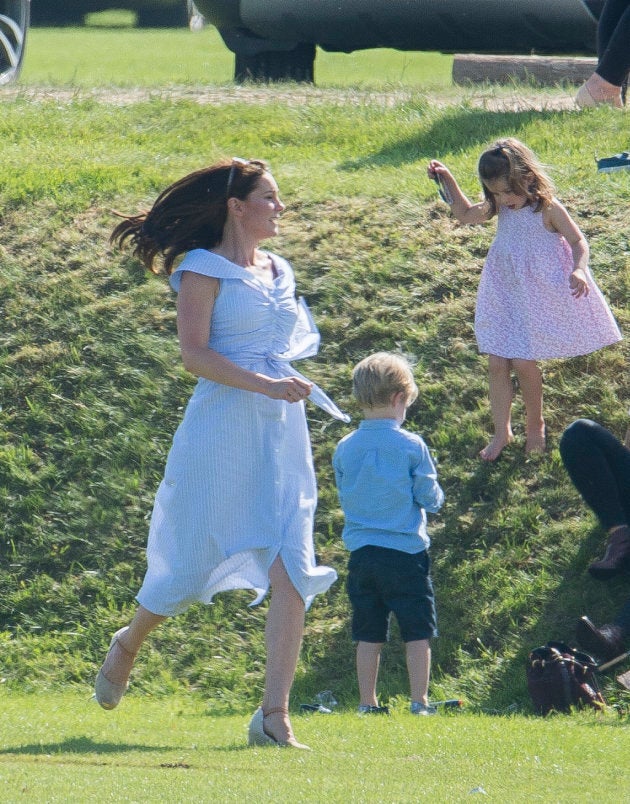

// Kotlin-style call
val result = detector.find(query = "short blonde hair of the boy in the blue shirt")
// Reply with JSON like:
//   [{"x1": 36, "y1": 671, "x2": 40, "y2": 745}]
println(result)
[{"x1": 352, "y1": 352, "x2": 418, "y2": 408}]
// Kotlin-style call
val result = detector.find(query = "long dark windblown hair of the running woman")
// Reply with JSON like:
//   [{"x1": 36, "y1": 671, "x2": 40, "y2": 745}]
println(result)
[{"x1": 110, "y1": 159, "x2": 267, "y2": 275}]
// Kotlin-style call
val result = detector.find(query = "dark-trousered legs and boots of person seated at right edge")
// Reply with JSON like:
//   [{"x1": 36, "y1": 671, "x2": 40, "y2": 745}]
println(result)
[{"x1": 560, "y1": 419, "x2": 630, "y2": 661}]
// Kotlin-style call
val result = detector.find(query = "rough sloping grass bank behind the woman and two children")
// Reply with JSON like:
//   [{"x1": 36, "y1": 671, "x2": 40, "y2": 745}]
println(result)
[{"x1": 0, "y1": 32, "x2": 630, "y2": 724}]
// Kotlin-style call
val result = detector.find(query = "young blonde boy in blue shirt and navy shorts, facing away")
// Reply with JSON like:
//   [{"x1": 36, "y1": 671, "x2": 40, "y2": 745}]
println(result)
[{"x1": 333, "y1": 352, "x2": 444, "y2": 715}]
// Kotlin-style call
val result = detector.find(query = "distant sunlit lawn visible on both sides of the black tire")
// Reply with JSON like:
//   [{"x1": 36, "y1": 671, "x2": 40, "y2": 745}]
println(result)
[{"x1": 20, "y1": 23, "x2": 453, "y2": 90}]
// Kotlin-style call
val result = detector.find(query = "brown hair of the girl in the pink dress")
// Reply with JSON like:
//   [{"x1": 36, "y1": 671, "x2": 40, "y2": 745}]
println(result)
[{"x1": 478, "y1": 137, "x2": 555, "y2": 215}]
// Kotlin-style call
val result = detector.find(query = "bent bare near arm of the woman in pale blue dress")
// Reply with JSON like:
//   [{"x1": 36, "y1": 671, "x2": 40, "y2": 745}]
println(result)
[{"x1": 177, "y1": 271, "x2": 312, "y2": 402}]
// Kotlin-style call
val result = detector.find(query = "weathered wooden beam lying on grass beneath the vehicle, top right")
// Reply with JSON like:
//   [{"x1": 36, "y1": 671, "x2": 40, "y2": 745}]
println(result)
[{"x1": 453, "y1": 53, "x2": 597, "y2": 86}]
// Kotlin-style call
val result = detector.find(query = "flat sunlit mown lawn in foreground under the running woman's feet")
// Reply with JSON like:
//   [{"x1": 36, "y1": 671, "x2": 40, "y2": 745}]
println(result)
[{"x1": 0, "y1": 694, "x2": 629, "y2": 804}]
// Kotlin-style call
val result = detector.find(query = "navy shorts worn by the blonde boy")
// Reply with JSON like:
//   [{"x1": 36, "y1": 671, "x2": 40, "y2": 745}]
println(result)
[{"x1": 348, "y1": 545, "x2": 437, "y2": 642}]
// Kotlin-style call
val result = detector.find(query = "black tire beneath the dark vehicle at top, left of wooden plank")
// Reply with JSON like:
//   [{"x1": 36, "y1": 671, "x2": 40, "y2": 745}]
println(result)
[{"x1": 234, "y1": 42, "x2": 315, "y2": 84}]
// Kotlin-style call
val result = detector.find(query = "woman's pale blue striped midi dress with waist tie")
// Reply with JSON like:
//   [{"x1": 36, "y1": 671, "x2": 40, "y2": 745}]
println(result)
[{"x1": 137, "y1": 249, "x2": 348, "y2": 616}]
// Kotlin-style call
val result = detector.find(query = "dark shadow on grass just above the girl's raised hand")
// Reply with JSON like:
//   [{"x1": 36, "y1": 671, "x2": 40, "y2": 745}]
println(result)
[{"x1": 339, "y1": 108, "x2": 558, "y2": 172}]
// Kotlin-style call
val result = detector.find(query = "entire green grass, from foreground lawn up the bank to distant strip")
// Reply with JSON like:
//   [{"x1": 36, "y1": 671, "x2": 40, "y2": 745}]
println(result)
[{"x1": 0, "y1": 22, "x2": 630, "y2": 802}]
